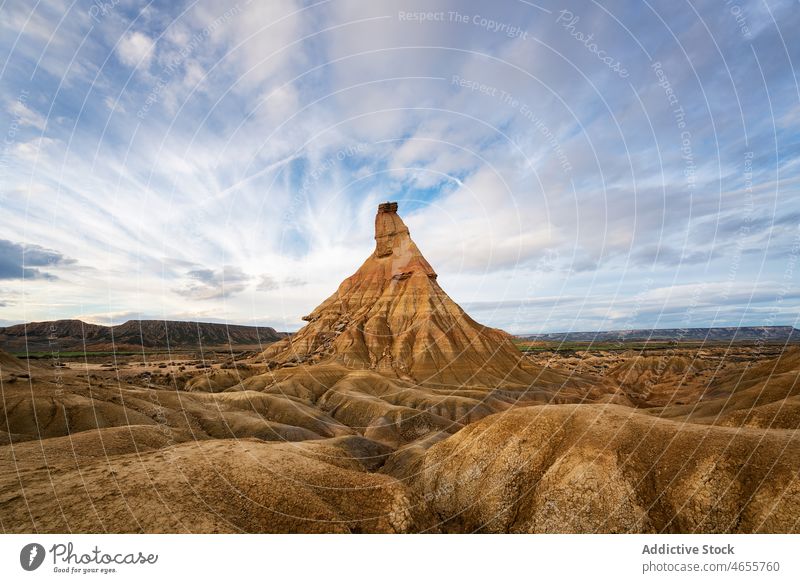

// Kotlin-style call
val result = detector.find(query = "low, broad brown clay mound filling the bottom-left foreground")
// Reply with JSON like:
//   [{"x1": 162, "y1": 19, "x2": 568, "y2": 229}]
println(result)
[{"x1": 0, "y1": 434, "x2": 419, "y2": 533}]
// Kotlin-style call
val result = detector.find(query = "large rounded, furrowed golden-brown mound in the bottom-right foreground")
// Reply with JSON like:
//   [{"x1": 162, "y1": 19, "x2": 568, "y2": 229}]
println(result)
[{"x1": 411, "y1": 405, "x2": 800, "y2": 533}]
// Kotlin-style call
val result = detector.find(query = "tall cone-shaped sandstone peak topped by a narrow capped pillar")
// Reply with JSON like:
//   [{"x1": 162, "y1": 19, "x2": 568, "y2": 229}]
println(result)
[{"x1": 262, "y1": 203, "x2": 532, "y2": 386}]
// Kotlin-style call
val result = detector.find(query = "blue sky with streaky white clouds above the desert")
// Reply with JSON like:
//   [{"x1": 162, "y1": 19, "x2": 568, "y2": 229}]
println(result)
[{"x1": 0, "y1": 0, "x2": 800, "y2": 333}]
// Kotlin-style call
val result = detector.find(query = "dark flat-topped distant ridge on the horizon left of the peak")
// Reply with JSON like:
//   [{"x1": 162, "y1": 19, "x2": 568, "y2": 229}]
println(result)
[{"x1": 0, "y1": 320, "x2": 287, "y2": 353}]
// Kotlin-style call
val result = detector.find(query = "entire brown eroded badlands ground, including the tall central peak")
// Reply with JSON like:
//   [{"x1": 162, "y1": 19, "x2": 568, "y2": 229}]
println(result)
[{"x1": 0, "y1": 203, "x2": 800, "y2": 533}]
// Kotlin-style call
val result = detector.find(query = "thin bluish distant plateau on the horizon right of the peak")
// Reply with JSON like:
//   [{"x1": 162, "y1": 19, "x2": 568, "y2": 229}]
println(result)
[{"x1": 517, "y1": 326, "x2": 800, "y2": 342}]
